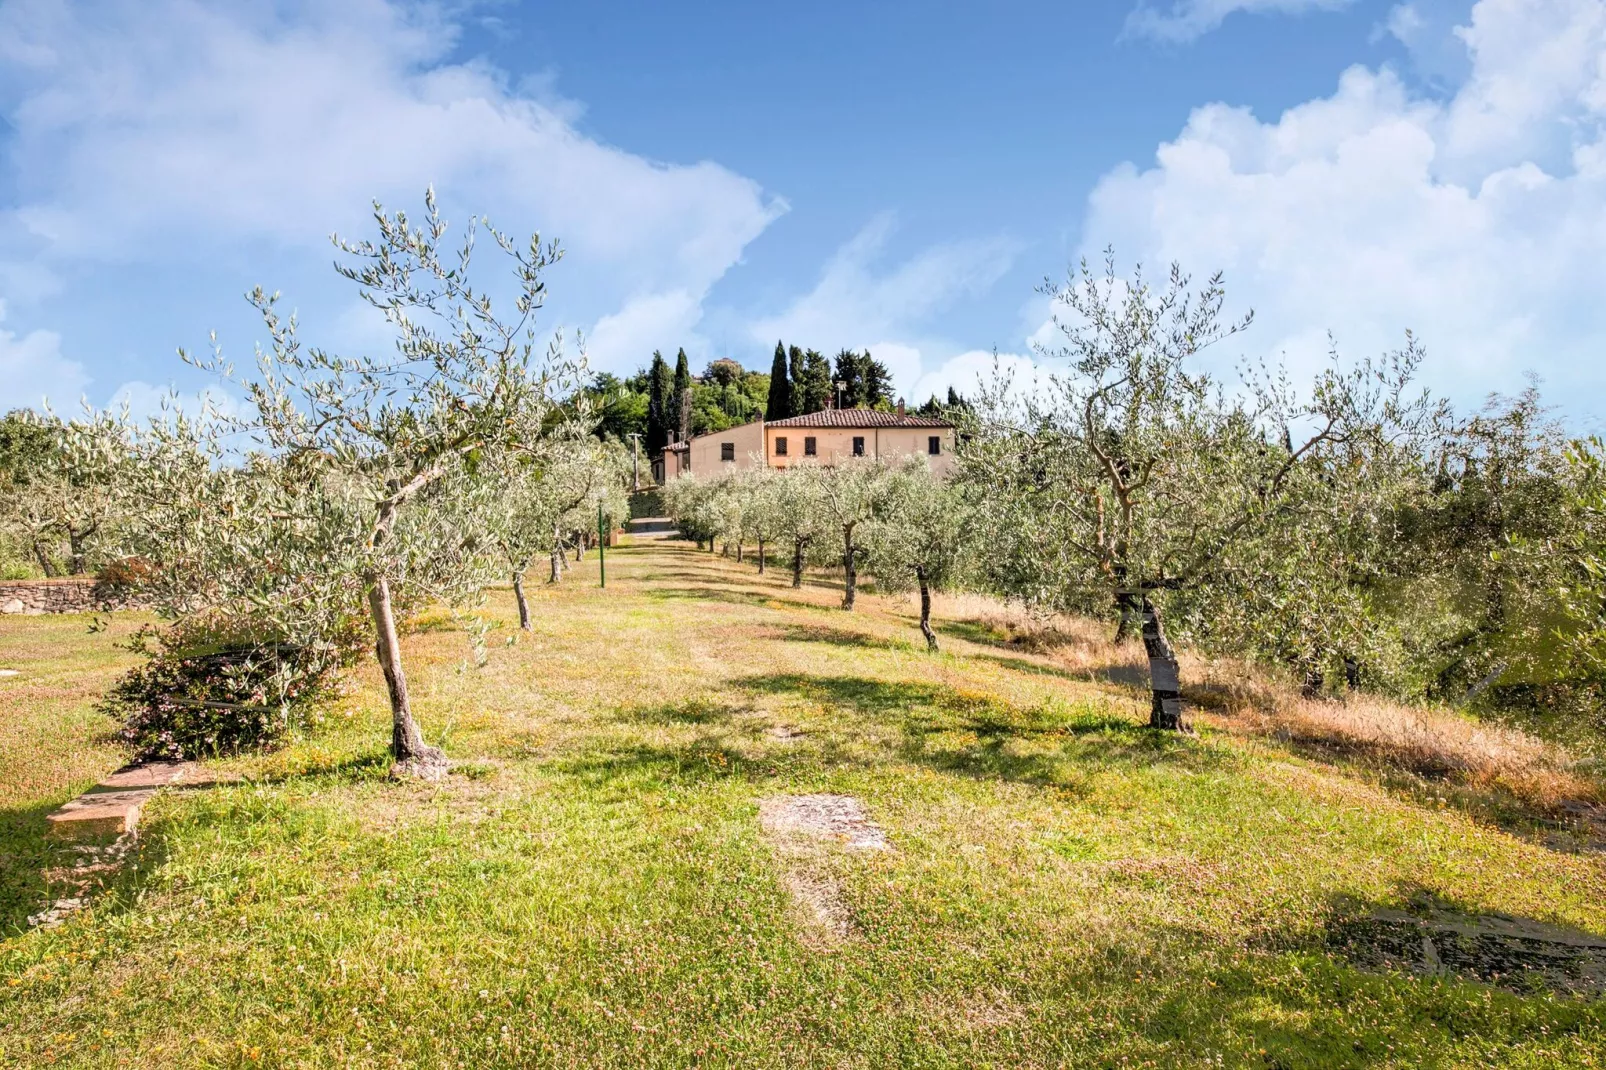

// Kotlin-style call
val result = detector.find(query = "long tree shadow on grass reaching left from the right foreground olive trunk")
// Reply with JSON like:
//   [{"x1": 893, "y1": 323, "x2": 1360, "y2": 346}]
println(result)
[{"x1": 736, "y1": 673, "x2": 1235, "y2": 787}]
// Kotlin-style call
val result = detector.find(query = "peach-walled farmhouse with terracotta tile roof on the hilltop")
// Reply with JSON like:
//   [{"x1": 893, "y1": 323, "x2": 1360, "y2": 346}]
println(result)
[{"x1": 662, "y1": 405, "x2": 954, "y2": 479}]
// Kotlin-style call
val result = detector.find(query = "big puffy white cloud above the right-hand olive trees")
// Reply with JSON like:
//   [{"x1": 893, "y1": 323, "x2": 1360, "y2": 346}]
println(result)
[{"x1": 1084, "y1": 0, "x2": 1606, "y2": 406}]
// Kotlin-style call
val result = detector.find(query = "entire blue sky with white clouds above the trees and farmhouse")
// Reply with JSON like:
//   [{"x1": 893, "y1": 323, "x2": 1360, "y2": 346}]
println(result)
[{"x1": 0, "y1": 0, "x2": 1606, "y2": 431}]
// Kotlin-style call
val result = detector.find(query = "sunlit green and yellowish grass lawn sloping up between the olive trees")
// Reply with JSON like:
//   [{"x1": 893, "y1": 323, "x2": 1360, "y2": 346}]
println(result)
[{"x1": 0, "y1": 543, "x2": 1606, "y2": 1068}]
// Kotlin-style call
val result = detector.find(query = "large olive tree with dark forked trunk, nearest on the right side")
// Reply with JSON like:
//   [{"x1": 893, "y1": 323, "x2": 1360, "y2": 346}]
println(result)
[{"x1": 967, "y1": 255, "x2": 1431, "y2": 729}]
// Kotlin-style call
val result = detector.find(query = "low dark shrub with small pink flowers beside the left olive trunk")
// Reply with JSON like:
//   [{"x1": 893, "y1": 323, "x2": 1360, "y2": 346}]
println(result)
[{"x1": 101, "y1": 620, "x2": 355, "y2": 760}]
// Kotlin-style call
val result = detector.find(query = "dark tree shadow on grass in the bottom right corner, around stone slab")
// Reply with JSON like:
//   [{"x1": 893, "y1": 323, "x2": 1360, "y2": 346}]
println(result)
[{"x1": 1117, "y1": 898, "x2": 1606, "y2": 1070}]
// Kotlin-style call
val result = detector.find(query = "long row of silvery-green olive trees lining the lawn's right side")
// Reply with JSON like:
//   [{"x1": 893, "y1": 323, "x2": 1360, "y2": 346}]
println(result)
[{"x1": 668, "y1": 260, "x2": 1606, "y2": 739}]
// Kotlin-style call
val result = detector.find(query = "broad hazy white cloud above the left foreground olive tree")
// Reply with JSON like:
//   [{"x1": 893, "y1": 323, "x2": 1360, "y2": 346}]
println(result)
[{"x1": 0, "y1": 0, "x2": 785, "y2": 380}]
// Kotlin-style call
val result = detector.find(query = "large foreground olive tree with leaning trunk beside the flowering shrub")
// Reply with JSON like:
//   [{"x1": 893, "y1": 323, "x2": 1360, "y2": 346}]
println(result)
[{"x1": 158, "y1": 191, "x2": 570, "y2": 776}]
